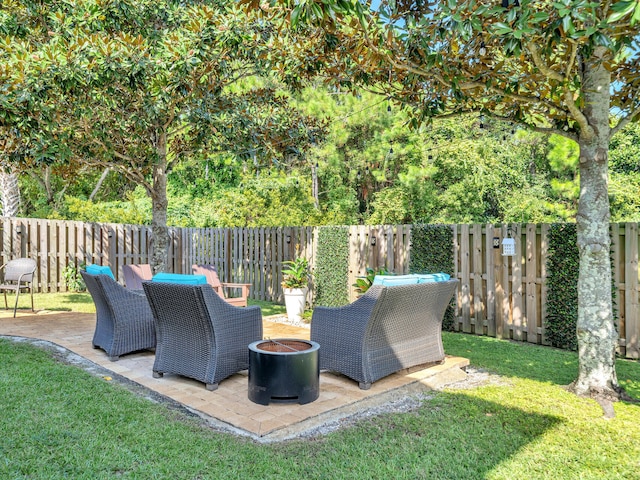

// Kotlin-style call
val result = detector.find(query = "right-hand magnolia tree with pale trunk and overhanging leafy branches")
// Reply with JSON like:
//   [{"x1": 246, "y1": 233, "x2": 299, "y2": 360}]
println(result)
[{"x1": 245, "y1": 0, "x2": 640, "y2": 414}]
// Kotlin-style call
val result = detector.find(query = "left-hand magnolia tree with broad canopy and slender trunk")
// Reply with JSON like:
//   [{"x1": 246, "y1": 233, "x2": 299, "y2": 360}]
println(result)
[{"x1": 0, "y1": 0, "x2": 322, "y2": 271}]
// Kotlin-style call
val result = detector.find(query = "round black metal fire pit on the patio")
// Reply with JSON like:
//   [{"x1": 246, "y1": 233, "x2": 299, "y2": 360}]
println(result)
[{"x1": 249, "y1": 338, "x2": 320, "y2": 405}]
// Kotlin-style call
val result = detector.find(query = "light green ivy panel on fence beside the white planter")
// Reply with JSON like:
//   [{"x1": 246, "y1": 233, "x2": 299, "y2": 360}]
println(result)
[{"x1": 315, "y1": 227, "x2": 349, "y2": 307}]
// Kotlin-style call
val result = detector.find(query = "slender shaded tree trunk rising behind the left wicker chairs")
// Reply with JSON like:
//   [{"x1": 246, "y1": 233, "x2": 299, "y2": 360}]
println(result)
[{"x1": 148, "y1": 132, "x2": 169, "y2": 273}]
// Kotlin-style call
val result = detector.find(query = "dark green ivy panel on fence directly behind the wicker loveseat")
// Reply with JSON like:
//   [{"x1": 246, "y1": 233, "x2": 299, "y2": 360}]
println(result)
[{"x1": 409, "y1": 225, "x2": 456, "y2": 331}]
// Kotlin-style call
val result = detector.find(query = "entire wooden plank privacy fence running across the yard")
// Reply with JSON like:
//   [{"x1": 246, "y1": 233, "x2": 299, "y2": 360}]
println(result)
[{"x1": 0, "y1": 218, "x2": 640, "y2": 358}]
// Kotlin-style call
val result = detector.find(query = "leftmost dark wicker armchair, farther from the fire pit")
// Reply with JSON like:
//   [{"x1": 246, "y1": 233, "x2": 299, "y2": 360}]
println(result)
[{"x1": 80, "y1": 271, "x2": 156, "y2": 362}]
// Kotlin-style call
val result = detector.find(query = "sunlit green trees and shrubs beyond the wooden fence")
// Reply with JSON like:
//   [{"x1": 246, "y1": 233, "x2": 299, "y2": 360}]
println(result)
[{"x1": 13, "y1": 89, "x2": 640, "y2": 227}]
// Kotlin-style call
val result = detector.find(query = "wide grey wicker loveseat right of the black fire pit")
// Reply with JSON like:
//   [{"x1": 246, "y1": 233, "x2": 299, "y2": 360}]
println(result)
[{"x1": 311, "y1": 280, "x2": 458, "y2": 390}]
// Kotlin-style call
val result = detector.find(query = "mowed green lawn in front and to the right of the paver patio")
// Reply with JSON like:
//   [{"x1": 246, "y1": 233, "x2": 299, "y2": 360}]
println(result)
[{"x1": 0, "y1": 294, "x2": 640, "y2": 480}]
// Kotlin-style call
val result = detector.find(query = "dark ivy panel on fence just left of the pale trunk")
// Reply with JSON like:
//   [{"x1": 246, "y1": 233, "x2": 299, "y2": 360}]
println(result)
[{"x1": 545, "y1": 223, "x2": 580, "y2": 350}]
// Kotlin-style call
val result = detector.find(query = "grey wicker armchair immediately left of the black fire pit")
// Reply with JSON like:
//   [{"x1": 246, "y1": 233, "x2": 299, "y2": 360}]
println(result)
[{"x1": 142, "y1": 282, "x2": 262, "y2": 390}]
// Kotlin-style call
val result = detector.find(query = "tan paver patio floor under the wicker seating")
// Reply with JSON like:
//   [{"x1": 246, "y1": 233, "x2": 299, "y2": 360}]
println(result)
[{"x1": 0, "y1": 311, "x2": 469, "y2": 442}]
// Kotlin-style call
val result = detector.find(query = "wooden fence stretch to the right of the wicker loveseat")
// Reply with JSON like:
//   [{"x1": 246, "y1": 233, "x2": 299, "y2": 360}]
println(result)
[{"x1": 453, "y1": 223, "x2": 640, "y2": 358}]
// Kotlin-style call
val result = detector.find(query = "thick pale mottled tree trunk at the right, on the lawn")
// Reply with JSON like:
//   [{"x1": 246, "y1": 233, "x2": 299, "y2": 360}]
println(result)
[{"x1": 571, "y1": 47, "x2": 620, "y2": 408}]
